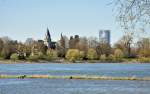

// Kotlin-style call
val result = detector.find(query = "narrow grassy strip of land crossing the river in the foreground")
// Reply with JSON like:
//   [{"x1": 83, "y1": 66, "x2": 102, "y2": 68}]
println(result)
[{"x1": 0, "y1": 75, "x2": 150, "y2": 81}]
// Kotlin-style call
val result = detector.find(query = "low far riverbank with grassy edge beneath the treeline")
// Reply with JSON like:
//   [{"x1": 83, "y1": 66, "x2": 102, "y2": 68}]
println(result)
[{"x1": 0, "y1": 59, "x2": 150, "y2": 64}]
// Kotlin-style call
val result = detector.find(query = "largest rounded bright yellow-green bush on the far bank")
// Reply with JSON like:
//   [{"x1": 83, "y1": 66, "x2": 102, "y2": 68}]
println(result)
[{"x1": 65, "y1": 49, "x2": 80, "y2": 62}]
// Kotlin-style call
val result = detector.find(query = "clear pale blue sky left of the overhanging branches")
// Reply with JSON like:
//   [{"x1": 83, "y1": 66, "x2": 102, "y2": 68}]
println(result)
[{"x1": 0, "y1": 0, "x2": 122, "y2": 44}]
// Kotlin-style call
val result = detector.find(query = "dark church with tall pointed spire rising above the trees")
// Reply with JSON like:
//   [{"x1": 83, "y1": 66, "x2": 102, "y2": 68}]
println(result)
[{"x1": 44, "y1": 28, "x2": 56, "y2": 49}]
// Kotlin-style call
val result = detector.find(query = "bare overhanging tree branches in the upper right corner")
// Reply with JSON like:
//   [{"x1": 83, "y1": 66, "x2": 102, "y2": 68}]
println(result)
[{"x1": 114, "y1": 0, "x2": 150, "y2": 32}]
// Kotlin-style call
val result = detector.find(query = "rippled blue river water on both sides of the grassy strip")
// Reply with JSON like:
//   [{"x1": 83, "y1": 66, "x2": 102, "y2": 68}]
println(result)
[{"x1": 0, "y1": 63, "x2": 150, "y2": 94}]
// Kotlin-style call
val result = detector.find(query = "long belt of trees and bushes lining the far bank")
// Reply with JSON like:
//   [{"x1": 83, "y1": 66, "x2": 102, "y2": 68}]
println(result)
[{"x1": 0, "y1": 35, "x2": 150, "y2": 62}]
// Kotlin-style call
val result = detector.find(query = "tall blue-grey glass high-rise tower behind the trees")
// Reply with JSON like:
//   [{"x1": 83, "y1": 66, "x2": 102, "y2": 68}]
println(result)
[{"x1": 99, "y1": 30, "x2": 110, "y2": 44}]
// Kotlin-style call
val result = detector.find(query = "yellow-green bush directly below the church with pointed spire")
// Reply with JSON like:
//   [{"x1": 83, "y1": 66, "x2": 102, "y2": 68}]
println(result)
[{"x1": 46, "y1": 49, "x2": 58, "y2": 60}]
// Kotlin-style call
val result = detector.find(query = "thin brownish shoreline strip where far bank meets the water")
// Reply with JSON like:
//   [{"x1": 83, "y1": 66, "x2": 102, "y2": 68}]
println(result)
[{"x1": 0, "y1": 60, "x2": 150, "y2": 64}]
